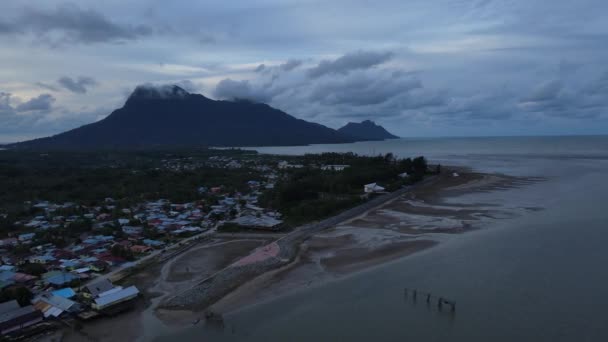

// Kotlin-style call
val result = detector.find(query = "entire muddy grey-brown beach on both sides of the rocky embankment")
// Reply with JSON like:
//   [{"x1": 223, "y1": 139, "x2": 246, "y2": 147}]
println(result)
[{"x1": 47, "y1": 169, "x2": 539, "y2": 341}]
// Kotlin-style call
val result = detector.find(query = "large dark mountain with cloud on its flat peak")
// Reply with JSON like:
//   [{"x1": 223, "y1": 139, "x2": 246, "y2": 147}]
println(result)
[{"x1": 13, "y1": 86, "x2": 356, "y2": 148}]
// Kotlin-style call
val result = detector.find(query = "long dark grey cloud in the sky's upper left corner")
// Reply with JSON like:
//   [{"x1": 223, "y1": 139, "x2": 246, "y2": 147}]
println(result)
[{"x1": 0, "y1": 4, "x2": 153, "y2": 45}]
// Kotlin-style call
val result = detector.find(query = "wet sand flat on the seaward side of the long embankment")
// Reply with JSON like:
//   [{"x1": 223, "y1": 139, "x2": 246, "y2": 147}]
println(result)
[{"x1": 211, "y1": 169, "x2": 541, "y2": 314}]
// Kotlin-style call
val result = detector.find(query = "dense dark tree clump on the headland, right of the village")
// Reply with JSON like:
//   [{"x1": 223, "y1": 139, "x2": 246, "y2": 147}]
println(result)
[{"x1": 261, "y1": 153, "x2": 427, "y2": 225}]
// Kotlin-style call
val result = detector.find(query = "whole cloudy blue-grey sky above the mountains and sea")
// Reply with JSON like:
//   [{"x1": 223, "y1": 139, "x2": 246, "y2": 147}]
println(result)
[{"x1": 0, "y1": 0, "x2": 608, "y2": 142}]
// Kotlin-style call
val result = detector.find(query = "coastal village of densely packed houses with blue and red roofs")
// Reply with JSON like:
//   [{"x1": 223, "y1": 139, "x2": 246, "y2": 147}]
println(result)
[{"x1": 0, "y1": 156, "x2": 408, "y2": 337}]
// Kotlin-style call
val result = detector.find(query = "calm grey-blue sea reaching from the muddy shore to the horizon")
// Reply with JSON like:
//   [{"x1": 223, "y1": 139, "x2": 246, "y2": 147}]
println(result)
[{"x1": 157, "y1": 136, "x2": 608, "y2": 342}]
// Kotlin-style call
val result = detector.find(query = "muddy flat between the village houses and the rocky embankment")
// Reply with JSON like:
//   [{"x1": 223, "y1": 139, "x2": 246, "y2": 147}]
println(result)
[{"x1": 56, "y1": 239, "x2": 269, "y2": 342}]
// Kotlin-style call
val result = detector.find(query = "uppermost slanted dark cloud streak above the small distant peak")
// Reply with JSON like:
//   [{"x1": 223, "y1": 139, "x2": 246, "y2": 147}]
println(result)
[{"x1": 308, "y1": 51, "x2": 393, "y2": 78}]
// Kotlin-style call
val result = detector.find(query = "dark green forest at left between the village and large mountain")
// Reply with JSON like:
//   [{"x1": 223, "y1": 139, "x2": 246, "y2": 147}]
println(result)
[{"x1": 0, "y1": 149, "x2": 259, "y2": 218}]
